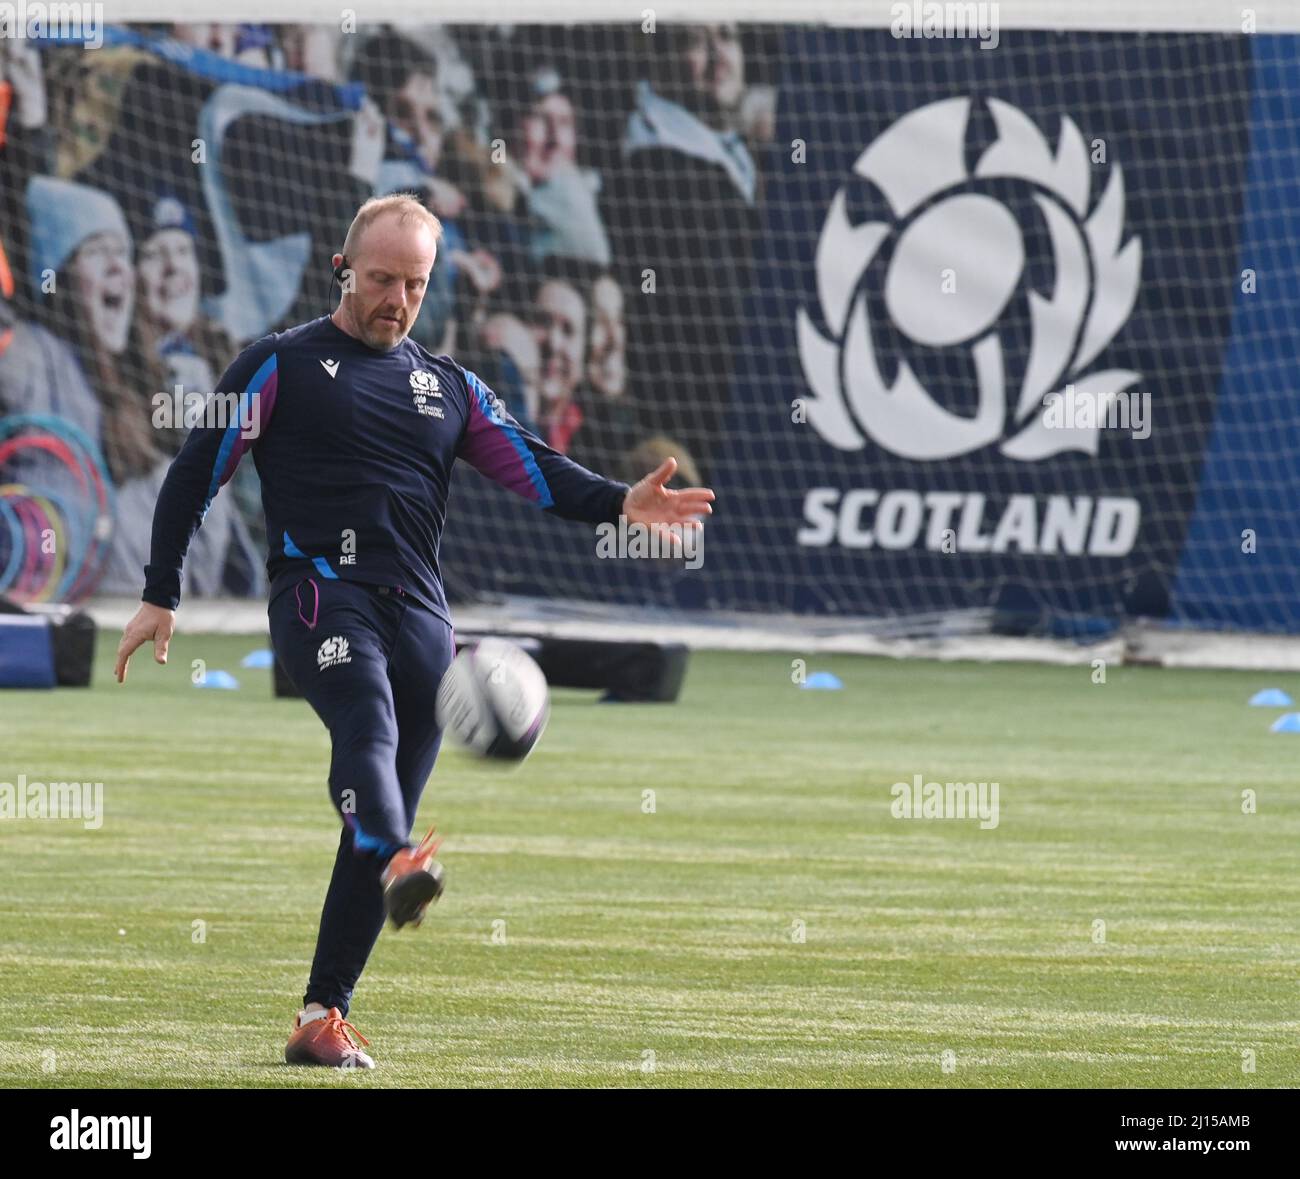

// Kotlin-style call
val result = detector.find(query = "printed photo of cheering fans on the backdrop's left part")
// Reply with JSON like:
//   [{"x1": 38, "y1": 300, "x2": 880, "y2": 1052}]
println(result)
[{"x1": 0, "y1": 25, "x2": 776, "y2": 602}]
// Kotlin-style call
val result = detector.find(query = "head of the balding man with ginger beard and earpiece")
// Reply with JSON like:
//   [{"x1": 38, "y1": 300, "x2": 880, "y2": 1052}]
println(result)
[{"x1": 334, "y1": 216, "x2": 438, "y2": 352}]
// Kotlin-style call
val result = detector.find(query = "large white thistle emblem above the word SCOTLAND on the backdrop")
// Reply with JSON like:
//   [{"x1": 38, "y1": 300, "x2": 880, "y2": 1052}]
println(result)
[{"x1": 797, "y1": 99, "x2": 1141, "y2": 461}]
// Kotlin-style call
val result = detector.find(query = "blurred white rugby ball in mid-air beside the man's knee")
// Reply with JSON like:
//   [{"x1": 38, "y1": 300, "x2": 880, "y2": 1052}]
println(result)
[{"x1": 437, "y1": 638, "x2": 551, "y2": 762}]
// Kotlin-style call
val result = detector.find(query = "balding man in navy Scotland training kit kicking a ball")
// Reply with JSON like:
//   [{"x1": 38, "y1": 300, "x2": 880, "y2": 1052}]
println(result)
[{"x1": 116, "y1": 195, "x2": 714, "y2": 1069}]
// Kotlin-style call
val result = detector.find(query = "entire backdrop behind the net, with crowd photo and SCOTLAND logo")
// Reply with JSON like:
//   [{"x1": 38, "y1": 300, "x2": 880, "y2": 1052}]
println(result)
[{"x1": 0, "y1": 18, "x2": 1300, "y2": 636}]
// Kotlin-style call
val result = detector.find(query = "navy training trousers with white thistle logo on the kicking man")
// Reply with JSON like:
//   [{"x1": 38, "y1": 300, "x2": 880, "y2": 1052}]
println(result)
[{"x1": 267, "y1": 577, "x2": 455, "y2": 1015}]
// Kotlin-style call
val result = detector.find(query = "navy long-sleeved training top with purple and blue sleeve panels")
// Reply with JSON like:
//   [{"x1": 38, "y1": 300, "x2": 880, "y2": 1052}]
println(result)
[{"x1": 143, "y1": 316, "x2": 628, "y2": 621}]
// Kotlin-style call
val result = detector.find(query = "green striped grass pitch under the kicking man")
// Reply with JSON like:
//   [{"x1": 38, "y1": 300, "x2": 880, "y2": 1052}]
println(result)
[{"x1": 0, "y1": 636, "x2": 1300, "y2": 1088}]
